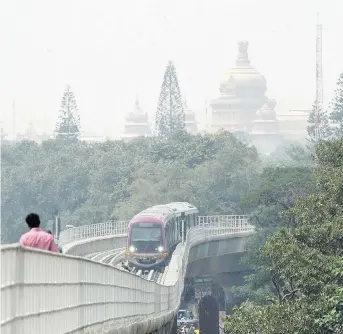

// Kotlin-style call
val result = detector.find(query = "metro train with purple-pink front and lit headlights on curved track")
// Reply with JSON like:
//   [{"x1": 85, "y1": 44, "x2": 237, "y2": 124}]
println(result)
[{"x1": 125, "y1": 202, "x2": 198, "y2": 269}]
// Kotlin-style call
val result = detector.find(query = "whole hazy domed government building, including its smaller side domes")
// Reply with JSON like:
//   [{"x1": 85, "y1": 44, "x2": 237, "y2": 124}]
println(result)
[{"x1": 121, "y1": 41, "x2": 310, "y2": 154}]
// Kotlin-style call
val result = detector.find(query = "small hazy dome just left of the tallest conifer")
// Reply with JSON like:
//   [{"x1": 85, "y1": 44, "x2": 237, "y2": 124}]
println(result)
[{"x1": 121, "y1": 99, "x2": 151, "y2": 141}]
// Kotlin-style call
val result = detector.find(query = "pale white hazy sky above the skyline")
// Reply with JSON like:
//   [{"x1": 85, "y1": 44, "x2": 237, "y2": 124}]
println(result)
[{"x1": 0, "y1": 0, "x2": 343, "y2": 135}]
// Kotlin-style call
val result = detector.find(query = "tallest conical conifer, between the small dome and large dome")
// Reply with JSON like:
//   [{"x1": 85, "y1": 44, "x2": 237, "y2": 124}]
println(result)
[{"x1": 155, "y1": 61, "x2": 185, "y2": 136}]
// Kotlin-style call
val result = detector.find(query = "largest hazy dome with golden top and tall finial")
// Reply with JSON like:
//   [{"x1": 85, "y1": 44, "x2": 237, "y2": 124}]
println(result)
[{"x1": 210, "y1": 42, "x2": 267, "y2": 133}]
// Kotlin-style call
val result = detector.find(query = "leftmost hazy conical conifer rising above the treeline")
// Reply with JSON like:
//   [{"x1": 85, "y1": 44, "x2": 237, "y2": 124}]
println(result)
[{"x1": 55, "y1": 85, "x2": 80, "y2": 140}]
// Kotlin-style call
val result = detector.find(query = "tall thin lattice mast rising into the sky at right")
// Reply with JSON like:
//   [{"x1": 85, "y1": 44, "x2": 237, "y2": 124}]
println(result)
[{"x1": 315, "y1": 13, "x2": 323, "y2": 139}]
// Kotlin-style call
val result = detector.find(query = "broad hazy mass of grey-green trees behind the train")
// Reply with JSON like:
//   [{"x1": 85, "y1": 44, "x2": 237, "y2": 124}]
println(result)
[{"x1": 1, "y1": 132, "x2": 259, "y2": 242}]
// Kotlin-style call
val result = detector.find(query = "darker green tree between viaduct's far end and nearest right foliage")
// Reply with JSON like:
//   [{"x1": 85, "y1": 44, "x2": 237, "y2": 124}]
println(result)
[{"x1": 229, "y1": 166, "x2": 316, "y2": 305}]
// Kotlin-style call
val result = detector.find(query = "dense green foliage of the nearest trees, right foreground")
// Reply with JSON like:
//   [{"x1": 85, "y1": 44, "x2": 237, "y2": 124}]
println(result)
[{"x1": 226, "y1": 139, "x2": 343, "y2": 334}]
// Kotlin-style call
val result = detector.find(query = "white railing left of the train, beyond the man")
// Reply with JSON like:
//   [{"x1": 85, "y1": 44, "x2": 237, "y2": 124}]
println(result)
[{"x1": 58, "y1": 221, "x2": 128, "y2": 246}]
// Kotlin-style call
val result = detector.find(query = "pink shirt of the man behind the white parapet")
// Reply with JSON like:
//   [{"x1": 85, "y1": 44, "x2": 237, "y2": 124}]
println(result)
[{"x1": 19, "y1": 227, "x2": 59, "y2": 253}]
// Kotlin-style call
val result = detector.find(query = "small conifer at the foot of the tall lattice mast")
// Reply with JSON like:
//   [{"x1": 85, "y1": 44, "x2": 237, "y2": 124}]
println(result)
[{"x1": 307, "y1": 101, "x2": 332, "y2": 143}]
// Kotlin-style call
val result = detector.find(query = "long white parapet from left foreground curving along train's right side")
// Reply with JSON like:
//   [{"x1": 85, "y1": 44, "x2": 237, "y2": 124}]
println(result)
[{"x1": 1, "y1": 220, "x2": 254, "y2": 334}]
